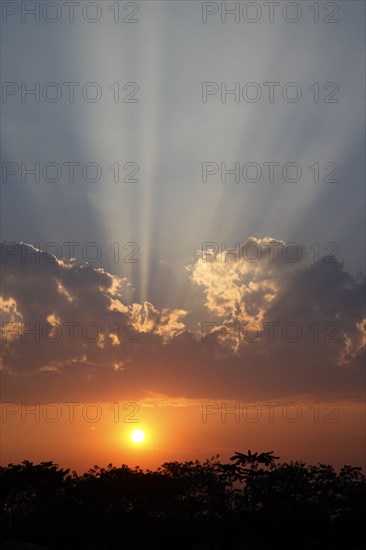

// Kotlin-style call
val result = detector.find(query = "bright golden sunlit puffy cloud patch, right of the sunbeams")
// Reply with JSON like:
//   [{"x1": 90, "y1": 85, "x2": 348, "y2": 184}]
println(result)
[{"x1": 189, "y1": 237, "x2": 303, "y2": 323}]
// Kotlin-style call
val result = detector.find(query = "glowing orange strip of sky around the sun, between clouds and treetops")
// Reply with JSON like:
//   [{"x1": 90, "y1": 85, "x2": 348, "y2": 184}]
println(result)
[{"x1": 1, "y1": 399, "x2": 365, "y2": 472}]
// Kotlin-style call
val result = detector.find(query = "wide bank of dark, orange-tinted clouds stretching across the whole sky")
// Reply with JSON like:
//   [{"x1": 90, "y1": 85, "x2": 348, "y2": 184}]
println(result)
[{"x1": 2, "y1": 243, "x2": 365, "y2": 402}]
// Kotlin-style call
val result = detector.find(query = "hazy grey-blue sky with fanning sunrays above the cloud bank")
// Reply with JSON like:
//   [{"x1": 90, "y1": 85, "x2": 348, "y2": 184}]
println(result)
[{"x1": 2, "y1": 2, "x2": 364, "y2": 306}]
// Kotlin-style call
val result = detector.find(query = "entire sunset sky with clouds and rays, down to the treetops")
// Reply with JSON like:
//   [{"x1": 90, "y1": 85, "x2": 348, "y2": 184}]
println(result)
[{"x1": 1, "y1": 0, "x2": 366, "y2": 470}]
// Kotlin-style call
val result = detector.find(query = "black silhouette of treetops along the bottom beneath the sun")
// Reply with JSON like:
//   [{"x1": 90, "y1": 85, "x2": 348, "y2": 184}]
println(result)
[{"x1": 0, "y1": 451, "x2": 366, "y2": 550}]
